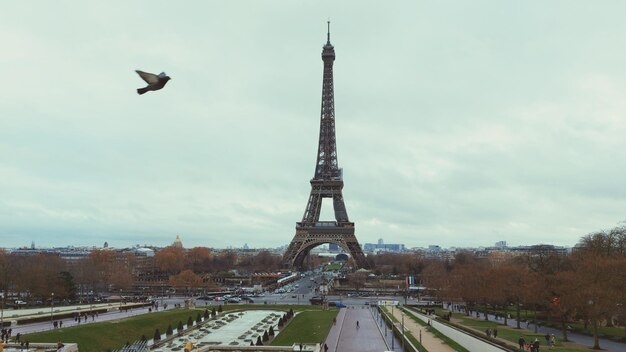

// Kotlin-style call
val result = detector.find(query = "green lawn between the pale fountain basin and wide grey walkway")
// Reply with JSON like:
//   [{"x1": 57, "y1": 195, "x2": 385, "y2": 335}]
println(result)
[{"x1": 268, "y1": 306, "x2": 339, "y2": 346}]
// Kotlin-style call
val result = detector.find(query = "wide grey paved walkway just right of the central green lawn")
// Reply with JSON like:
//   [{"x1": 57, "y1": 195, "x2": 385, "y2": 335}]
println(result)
[{"x1": 325, "y1": 307, "x2": 387, "y2": 352}]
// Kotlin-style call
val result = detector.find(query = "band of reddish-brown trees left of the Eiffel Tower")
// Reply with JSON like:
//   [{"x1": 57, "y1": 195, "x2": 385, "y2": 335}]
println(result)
[{"x1": 0, "y1": 247, "x2": 281, "y2": 304}]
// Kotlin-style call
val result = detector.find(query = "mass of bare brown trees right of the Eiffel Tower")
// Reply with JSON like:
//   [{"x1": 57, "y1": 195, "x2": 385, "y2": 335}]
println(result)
[{"x1": 422, "y1": 226, "x2": 626, "y2": 348}]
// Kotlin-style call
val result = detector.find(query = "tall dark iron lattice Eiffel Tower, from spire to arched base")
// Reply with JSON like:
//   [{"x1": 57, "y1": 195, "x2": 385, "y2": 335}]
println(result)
[{"x1": 283, "y1": 23, "x2": 368, "y2": 269}]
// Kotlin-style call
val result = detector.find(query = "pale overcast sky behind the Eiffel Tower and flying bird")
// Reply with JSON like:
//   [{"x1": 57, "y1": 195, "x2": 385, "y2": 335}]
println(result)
[{"x1": 0, "y1": 0, "x2": 626, "y2": 247}]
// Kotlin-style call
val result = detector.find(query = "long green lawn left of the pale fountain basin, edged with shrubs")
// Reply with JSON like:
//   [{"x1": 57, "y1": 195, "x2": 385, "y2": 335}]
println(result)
[{"x1": 21, "y1": 309, "x2": 203, "y2": 352}]
